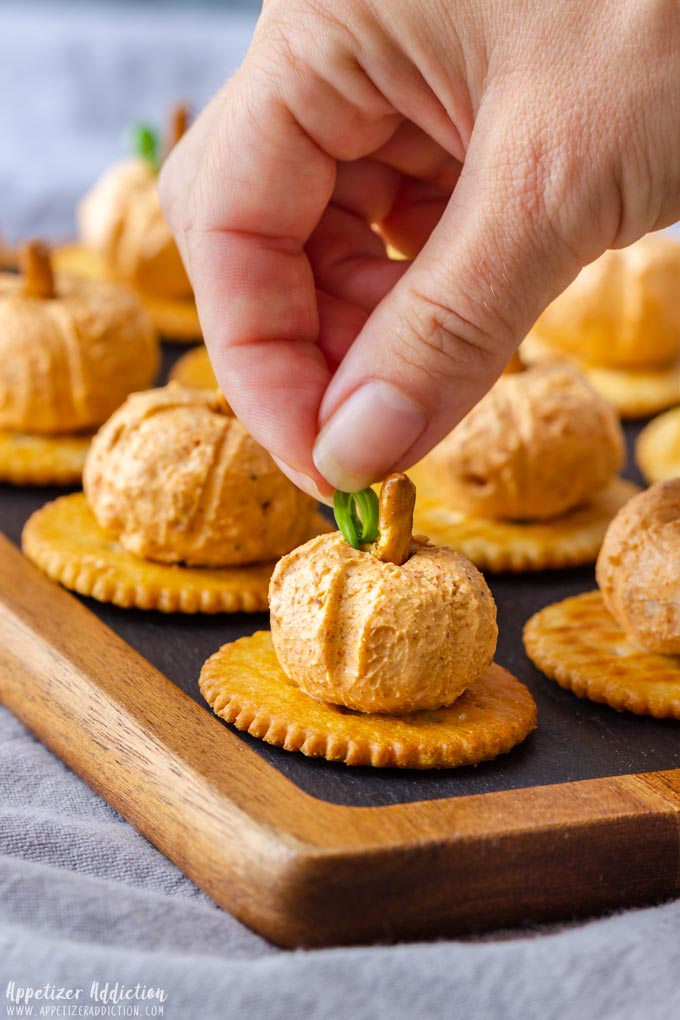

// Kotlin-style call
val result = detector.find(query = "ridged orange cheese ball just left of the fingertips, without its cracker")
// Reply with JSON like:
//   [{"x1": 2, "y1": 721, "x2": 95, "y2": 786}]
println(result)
[{"x1": 83, "y1": 384, "x2": 316, "y2": 566}]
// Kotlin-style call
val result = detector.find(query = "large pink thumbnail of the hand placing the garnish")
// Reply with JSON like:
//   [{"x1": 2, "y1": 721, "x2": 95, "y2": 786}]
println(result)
[{"x1": 313, "y1": 379, "x2": 427, "y2": 493}]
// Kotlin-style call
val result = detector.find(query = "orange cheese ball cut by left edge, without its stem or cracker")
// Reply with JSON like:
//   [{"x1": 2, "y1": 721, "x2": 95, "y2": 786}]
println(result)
[{"x1": 0, "y1": 273, "x2": 160, "y2": 435}]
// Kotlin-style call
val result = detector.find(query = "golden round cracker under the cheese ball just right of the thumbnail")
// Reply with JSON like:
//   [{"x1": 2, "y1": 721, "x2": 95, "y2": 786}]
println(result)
[{"x1": 409, "y1": 461, "x2": 639, "y2": 573}]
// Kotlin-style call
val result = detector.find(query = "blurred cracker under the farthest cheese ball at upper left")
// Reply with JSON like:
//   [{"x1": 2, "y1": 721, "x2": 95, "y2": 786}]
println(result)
[{"x1": 52, "y1": 244, "x2": 203, "y2": 344}]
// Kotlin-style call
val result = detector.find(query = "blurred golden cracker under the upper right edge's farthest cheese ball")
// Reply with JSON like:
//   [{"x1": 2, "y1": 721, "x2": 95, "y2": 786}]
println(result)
[{"x1": 520, "y1": 334, "x2": 680, "y2": 419}]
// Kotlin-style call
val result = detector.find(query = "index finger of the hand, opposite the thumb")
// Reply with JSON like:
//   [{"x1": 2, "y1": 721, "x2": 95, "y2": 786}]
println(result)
[{"x1": 174, "y1": 67, "x2": 334, "y2": 489}]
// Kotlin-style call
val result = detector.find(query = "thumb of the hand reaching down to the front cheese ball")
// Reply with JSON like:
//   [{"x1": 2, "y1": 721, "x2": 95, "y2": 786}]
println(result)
[{"x1": 314, "y1": 111, "x2": 587, "y2": 492}]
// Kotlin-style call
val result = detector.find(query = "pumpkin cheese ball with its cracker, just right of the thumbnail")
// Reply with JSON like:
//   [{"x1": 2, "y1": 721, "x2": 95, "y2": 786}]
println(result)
[{"x1": 414, "y1": 364, "x2": 636, "y2": 570}]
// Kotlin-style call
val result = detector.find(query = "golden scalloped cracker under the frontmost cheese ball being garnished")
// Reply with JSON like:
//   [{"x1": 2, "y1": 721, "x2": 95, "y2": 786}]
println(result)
[{"x1": 199, "y1": 630, "x2": 536, "y2": 769}]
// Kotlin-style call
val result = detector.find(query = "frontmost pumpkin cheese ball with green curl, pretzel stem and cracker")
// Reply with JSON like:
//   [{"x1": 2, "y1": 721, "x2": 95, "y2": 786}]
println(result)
[{"x1": 199, "y1": 474, "x2": 536, "y2": 768}]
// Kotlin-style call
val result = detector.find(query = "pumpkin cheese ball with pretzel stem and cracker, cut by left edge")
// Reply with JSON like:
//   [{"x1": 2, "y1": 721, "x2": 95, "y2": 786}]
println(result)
[{"x1": 0, "y1": 243, "x2": 159, "y2": 483}]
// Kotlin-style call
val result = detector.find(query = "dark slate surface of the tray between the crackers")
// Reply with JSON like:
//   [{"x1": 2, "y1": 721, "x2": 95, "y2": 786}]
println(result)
[{"x1": 0, "y1": 348, "x2": 680, "y2": 807}]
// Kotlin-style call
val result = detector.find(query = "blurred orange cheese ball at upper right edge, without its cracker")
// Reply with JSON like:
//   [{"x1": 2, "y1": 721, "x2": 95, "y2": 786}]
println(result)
[{"x1": 534, "y1": 234, "x2": 680, "y2": 368}]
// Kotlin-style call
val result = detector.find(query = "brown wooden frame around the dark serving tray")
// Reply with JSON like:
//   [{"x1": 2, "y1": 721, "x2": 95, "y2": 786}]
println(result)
[{"x1": 0, "y1": 536, "x2": 680, "y2": 947}]
